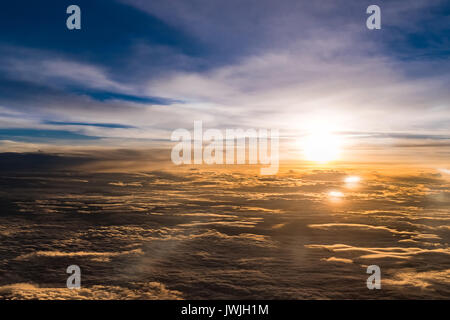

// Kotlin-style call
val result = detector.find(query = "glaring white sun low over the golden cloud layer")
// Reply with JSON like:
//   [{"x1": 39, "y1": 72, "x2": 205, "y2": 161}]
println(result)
[{"x1": 302, "y1": 131, "x2": 341, "y2": 163}]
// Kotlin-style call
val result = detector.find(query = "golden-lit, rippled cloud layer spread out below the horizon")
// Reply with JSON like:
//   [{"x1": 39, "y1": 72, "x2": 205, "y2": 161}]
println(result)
[{"x1": 0, "y1": 167, "x2": 450, "y2": 299}]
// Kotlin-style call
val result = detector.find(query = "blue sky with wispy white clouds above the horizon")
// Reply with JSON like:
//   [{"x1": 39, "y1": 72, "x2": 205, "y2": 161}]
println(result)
[{"x1": 0, "y1": 0, "x2": 450, "y2": 164}]
